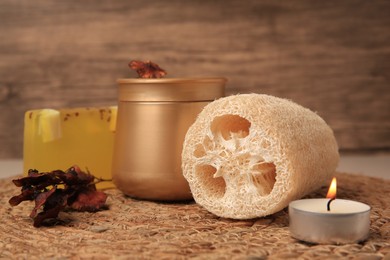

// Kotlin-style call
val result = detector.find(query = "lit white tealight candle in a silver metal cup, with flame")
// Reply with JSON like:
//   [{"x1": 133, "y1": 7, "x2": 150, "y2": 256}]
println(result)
[{"x1": 289, "y1": 178, "x2": 371, "y2": 244}]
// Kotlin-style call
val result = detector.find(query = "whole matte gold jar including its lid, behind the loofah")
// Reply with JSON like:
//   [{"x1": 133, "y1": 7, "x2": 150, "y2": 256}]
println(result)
[{"x1": 112, "y1": 78, "x2": 226, "y2": 201}]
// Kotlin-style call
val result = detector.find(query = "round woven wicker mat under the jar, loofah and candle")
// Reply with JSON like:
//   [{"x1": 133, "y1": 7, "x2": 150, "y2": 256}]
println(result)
[{"x1": 0, "y1": 173, "x2": 390, "y2": 259}]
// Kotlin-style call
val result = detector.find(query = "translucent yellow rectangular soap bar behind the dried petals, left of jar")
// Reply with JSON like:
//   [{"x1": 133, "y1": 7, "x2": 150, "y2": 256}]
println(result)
[{"x1": 23, "y1": 106, "x2": 117, "y2": 189}]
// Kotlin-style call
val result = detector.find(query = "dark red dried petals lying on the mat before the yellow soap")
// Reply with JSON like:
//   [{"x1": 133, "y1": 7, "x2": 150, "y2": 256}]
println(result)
[{"x1": 9, "y1": 166, "x2": 107, "y2": 227}]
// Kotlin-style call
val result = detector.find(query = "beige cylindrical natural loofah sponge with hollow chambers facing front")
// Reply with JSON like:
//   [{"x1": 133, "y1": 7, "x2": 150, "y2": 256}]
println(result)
[{"x1": 182, "y1": 94, "x2": 339, "y2": 219}]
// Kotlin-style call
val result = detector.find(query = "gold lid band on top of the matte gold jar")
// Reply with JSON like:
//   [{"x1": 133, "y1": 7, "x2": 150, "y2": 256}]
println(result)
[{"x1": 117, "y1": 77, "x2": 227, "y2": 102}]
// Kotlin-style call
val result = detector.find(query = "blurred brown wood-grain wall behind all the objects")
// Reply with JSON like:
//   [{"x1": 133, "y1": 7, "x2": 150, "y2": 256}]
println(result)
[{"x1": 0, "y1": 0, "x2": 390, "y2": 158}]
